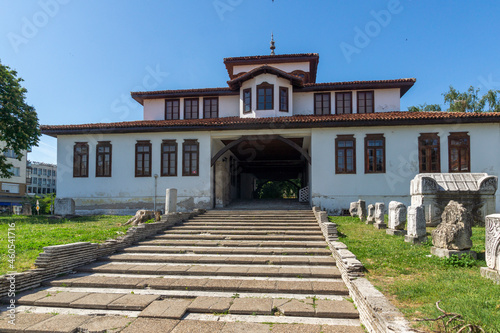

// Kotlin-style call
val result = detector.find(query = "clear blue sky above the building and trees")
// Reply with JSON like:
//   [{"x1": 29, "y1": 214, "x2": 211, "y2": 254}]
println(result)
[{"x1": 0, "y1": 0, "x2": 500, "y2": 163}]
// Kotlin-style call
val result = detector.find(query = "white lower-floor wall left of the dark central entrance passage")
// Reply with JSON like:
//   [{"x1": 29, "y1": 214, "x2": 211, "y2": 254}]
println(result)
[{"x1": 57, "y1": 132, "x2": 212, "y2": 214}]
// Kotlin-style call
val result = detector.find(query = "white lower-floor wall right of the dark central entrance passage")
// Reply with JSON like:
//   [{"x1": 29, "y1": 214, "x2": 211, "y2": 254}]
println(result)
[{"x1": 311, "y1": 124, "x2": 500, "y2": 213}]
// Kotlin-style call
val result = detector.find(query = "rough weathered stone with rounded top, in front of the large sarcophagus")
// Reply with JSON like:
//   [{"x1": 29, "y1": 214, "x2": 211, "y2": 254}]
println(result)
[{"x1": 431, "y1": 200, "x2": 476, "y2": 258}]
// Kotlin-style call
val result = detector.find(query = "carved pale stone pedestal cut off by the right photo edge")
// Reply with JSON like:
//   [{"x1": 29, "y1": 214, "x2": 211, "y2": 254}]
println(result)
[{"x1": 481, "y1": 214, "x2": 500, "y2": 284}]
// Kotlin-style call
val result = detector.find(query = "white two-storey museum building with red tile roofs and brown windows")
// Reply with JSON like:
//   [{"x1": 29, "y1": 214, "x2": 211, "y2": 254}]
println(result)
[{"x1": 42, "y1": 53, "x2": 500, "y2": 214}]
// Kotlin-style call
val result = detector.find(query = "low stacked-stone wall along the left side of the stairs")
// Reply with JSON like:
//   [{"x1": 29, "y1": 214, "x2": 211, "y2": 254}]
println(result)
[{"x1": 0, "y1": 209, "x2": 204, "y2": 297}]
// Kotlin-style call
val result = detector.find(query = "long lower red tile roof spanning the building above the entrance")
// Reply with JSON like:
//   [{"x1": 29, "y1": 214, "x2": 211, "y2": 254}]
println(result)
[{"x1": 41, "y1": 111, "x2": 500, "y2": 137}]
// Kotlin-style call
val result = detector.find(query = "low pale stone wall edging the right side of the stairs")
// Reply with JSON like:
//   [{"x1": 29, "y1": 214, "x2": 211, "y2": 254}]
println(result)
[{"x1": 313, "y1": 207, "x2": 414, "y2": 333}]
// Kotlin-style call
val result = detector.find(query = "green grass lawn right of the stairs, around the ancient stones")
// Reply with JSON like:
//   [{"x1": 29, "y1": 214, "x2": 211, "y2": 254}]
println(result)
[{"x1": 330, "y1": 217, "x2": 500, "y2": 332}]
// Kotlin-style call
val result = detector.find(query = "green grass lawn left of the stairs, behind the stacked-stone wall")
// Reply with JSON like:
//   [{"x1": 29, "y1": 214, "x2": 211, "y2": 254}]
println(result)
[{"x1": 0, "y1": 216, "x2": 130, "y2": 275}]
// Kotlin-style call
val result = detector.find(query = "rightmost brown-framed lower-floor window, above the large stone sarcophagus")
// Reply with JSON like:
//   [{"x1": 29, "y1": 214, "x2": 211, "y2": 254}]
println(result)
[{"x1": 448, "y1": 132, "x2": 470, "y2": 172}]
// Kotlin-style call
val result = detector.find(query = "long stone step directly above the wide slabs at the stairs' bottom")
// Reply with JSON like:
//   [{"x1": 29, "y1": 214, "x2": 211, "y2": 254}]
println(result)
[{"x1": 47, "y1": 275, "x2": 349, "y2": 295}]
